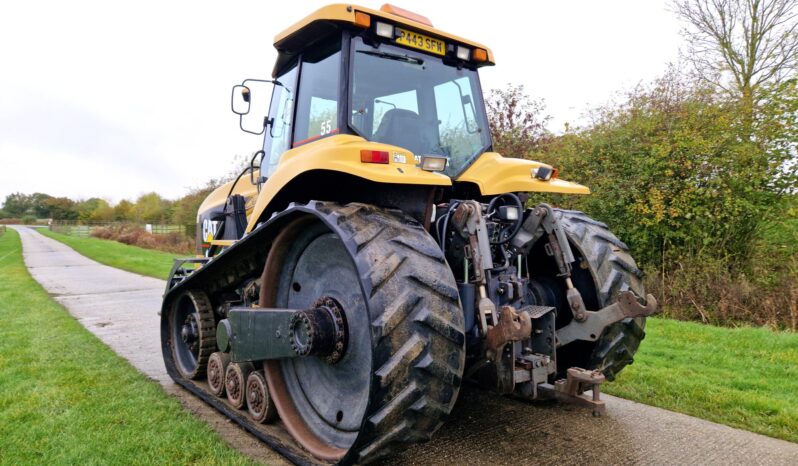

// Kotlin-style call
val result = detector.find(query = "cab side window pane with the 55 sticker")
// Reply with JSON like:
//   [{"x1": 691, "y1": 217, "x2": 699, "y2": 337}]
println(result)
[{"x1": 293, "y1": 41, "x2": 341, "y2": 147}]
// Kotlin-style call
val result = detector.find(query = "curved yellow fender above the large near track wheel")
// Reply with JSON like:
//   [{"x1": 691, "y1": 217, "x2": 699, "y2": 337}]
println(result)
[{"x1": 247, "y1": 134, "x2": 452, "y2": 232}]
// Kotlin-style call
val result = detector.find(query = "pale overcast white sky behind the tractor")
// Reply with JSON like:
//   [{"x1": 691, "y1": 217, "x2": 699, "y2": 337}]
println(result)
[{"x1": 0, "y1": 0, "x2": 681, "y2": 202}]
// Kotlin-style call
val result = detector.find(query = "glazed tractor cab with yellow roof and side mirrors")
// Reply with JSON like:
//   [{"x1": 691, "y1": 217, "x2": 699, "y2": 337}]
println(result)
[{"x1": 233, "y1": 5, "x2": 493, "y2": 179}]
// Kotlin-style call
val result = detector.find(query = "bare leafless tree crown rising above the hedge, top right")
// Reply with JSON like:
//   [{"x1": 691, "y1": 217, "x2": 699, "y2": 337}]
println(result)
[{"x1": 674, "y1": 0, "x2": 798, "y2": 110}]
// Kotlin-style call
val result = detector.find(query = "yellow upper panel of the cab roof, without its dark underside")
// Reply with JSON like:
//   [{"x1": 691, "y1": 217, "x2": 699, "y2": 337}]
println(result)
[{"x1": 274, "y1": 4, "x2": 495, "y2": 65}]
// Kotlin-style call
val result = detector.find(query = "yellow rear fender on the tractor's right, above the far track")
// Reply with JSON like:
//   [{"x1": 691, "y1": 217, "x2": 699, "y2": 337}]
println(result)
[{"x1": 456, "y1": 152, "x2": 590, "y2": 196}]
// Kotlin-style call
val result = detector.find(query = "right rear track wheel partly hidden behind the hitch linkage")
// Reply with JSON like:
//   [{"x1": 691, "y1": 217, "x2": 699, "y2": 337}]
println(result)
[{"x1": 530, "y1": 209, "x2": 646, "y2": 380}]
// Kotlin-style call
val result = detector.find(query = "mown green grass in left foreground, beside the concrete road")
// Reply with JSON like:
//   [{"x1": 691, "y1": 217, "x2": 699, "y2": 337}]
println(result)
[{"x1": 0, "y1": 229, "x2": 250, "y2": 465}]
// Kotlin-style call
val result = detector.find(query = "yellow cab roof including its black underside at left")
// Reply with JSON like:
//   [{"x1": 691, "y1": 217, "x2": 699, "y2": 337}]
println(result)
[{"x1": 274, "y1": 3, "x2": 494, "y2": 74}]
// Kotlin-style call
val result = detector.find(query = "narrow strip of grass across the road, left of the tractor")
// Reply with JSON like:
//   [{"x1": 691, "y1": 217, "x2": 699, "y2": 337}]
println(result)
[{"x1": 36, "y1": 228, "x2": 173, "y2": 280}]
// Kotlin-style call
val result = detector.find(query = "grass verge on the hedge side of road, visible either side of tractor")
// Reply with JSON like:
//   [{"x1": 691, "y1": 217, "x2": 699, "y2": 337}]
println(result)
[{"x1": 37, "y1": 229, "x2": 798, "y2": 442}]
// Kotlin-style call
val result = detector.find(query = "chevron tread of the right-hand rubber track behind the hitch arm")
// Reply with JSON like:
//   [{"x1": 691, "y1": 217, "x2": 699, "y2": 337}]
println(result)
[{"x1": 554, "y1": 209, "x2": 646, "y2": 380}]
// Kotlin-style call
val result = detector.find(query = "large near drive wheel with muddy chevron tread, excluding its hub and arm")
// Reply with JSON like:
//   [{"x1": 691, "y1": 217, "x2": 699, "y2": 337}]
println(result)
[{"x1": 259, "y1": 202, "x2": 465, "y2": 463}]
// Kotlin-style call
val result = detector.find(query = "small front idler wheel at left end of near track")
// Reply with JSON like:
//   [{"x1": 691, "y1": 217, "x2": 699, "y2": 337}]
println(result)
[{"x1": 168, "y1": 291, "x2": 216, "y2": 379}]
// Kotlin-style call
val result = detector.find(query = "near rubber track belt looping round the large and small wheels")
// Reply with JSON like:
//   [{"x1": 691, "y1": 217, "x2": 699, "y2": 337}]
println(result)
[{"x1": 162, "y1": 201, "x2": 465, "y2": 464}]
